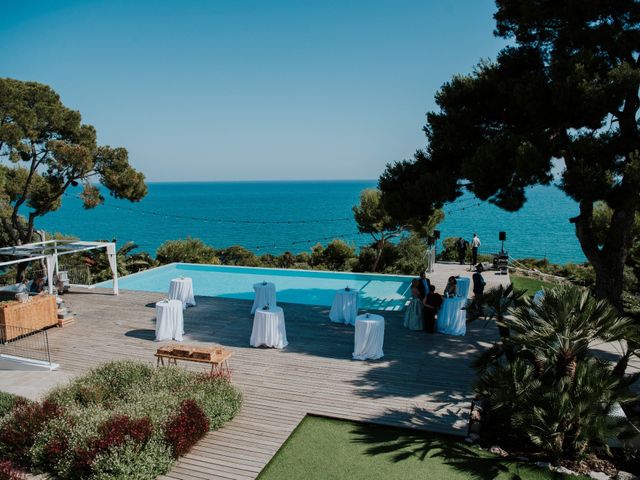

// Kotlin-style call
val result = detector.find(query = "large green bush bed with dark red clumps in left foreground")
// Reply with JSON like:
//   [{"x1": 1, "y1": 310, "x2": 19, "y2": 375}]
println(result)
[{"x1": 0, "y1": 361, "x2": 242, "y2": 479}]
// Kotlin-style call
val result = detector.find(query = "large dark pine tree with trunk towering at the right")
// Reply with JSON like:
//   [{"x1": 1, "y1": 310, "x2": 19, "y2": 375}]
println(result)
[{"x1": 380, "y1": 0, "x2": 640, "y2": 305}]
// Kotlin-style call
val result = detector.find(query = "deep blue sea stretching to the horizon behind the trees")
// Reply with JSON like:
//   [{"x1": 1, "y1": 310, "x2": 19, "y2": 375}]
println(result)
[{"x1": 37, "y1": 180, "x2": 585, "y2": 263}]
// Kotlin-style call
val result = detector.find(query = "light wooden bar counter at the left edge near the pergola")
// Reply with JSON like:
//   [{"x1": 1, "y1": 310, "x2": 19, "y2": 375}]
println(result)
[{"x1": 0, "y1": 295, "x2": 58, "y2": 340}]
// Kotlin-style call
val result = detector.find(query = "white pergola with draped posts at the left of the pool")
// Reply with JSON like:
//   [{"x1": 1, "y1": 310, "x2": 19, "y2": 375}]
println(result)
[{"x1": 0, "y1": 240, "x2": 119, "y2": 295}]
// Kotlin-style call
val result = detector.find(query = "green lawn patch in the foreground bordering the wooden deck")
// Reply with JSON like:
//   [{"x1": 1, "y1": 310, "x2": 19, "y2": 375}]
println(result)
[{"x1": 258, "y1": 416, "x2": 584, "y2": 480}]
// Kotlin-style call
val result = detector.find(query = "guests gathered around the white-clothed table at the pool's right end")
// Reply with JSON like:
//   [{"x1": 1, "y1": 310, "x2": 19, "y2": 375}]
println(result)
[{"x1": 404, "y1": 263, "x2": 486, "y2": 333}]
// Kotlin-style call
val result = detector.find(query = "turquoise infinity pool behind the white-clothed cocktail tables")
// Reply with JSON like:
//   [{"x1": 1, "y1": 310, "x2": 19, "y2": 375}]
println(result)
[{"x1": 96, "y1": 263, "x2": 411, "y2": 310}]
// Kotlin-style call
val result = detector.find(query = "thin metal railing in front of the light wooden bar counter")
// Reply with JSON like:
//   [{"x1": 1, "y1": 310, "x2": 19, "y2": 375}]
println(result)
[{"x1": 0, "y1": 324, "x2": 51, "y2": 365}]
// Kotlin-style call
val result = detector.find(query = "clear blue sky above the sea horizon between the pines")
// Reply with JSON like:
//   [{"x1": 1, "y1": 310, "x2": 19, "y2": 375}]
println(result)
[{"x1": 0, "y1": 0, "x2": 503, "y2": 181}]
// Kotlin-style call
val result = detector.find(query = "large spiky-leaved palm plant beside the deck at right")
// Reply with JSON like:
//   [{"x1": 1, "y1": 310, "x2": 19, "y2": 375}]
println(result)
[{"x1": 474, "y1": 286, "x2": 638, "y2": 460}]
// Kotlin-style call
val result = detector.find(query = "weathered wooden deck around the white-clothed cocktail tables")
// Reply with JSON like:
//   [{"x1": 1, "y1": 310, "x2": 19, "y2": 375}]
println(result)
[{"x1": 12, "y1": 264, "x2": 508, "y2": 480}]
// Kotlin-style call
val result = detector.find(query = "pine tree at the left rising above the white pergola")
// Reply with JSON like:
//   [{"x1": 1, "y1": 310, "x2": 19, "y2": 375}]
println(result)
[{"x1": 0, "y1": 78, "x2": 147, "y2": 248}]
